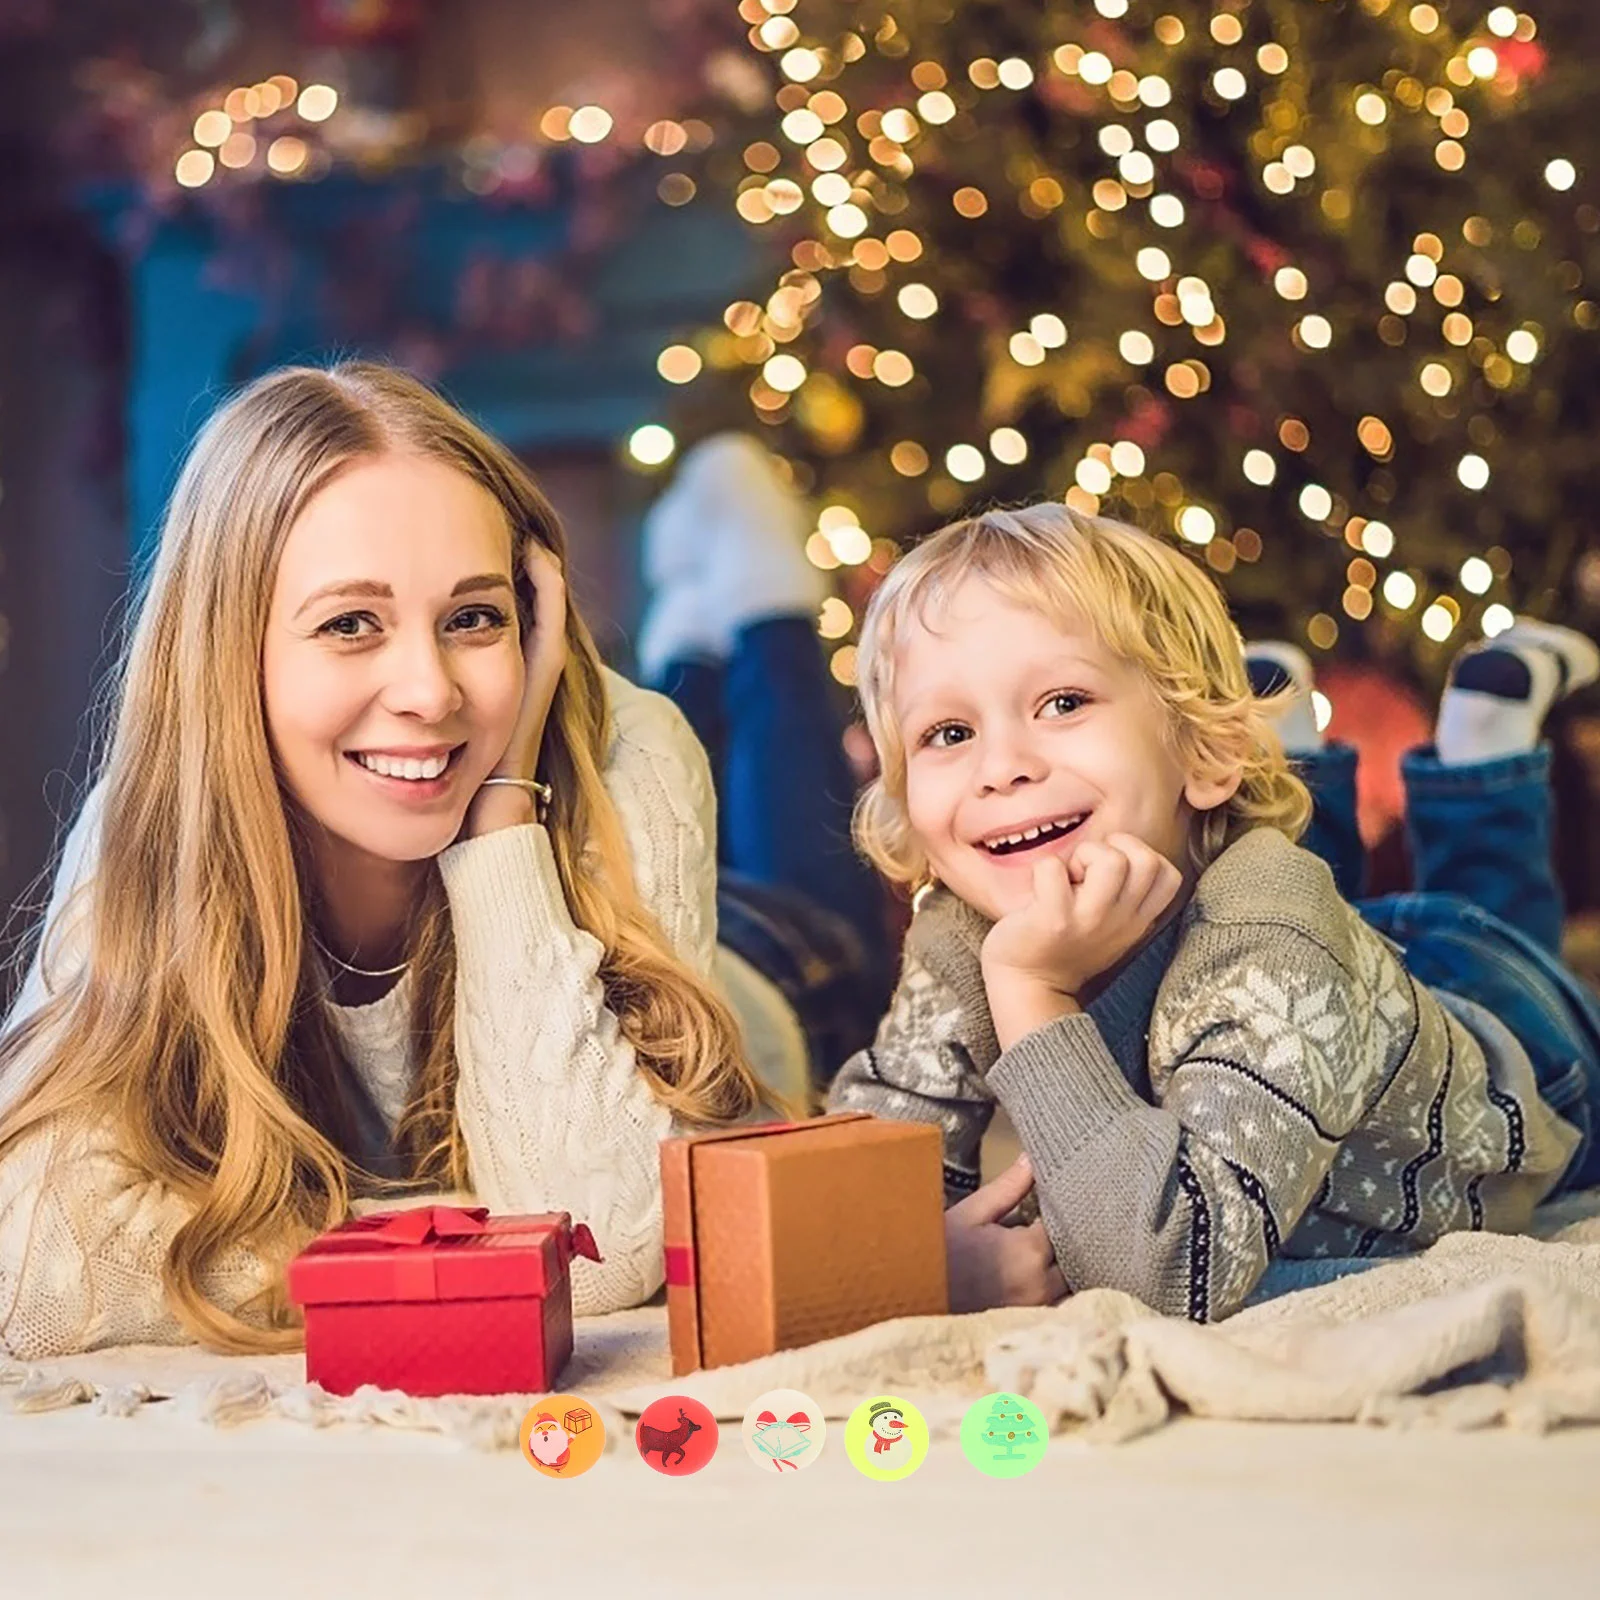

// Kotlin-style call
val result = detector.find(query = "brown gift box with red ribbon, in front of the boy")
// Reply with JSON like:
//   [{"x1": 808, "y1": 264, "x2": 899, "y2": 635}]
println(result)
[{"x1": 661, "y1": 1112, "x2": 949, "y2": 1374}]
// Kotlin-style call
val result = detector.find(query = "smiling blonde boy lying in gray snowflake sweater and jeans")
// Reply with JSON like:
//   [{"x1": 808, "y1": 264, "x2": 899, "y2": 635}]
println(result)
[{"x1": 829, "y1": 504, "x2": 1600, "y2": 1320}]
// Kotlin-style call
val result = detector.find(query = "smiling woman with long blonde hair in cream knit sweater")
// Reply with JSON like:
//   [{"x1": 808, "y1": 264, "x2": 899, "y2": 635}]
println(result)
[{"x1": 0, "y1": 365, "x2": 774, "y2": 1358}]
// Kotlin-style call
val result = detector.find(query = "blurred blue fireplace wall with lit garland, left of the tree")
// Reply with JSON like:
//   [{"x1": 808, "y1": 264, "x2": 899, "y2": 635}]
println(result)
[{"x1": 0, "y1": 0, "x2": 765, "y2": 960}]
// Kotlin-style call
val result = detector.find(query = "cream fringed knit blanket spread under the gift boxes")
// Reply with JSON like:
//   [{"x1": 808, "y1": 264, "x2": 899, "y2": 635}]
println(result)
[{"x1": 0, "y1": 1190, "x2": 1600, "y2": 1450}]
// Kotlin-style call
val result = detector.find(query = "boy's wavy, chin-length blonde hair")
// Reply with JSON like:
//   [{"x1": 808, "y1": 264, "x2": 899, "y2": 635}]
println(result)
[{"x1": 856, "y1": 502, "x2": 1310, "y2": 886}]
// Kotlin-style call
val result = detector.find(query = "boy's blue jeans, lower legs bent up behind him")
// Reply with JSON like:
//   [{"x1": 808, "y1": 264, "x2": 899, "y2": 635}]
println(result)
[{"x1": 1250, "y1": 744, "x2": 1600, "y2": 1304}]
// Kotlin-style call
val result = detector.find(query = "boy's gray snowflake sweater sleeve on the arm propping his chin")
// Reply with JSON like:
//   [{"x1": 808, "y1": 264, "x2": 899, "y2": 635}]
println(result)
[{"x1": 989, "y1": 923, "x2": 1373, "y2": 1322}]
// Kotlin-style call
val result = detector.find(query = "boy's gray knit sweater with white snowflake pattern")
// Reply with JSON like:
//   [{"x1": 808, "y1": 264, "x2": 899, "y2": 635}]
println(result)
[{"x1": 829, "y1": 829, "x2": 1579, "y2": 1322}]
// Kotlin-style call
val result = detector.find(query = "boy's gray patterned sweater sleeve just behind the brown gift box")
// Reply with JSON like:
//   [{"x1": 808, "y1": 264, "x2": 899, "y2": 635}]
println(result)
[{"x1": 827, "y1": 947, "x2": 994, "y2": 1205}]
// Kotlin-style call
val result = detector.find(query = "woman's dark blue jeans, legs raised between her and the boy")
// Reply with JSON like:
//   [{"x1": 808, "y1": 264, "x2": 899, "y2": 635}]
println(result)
[{"x1": 651, "y1": 616, "x2": 896, "y2": 1085}]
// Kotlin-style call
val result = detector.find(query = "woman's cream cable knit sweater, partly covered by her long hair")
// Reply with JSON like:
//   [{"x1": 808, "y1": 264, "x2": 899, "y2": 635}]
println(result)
[{"x1": 0, "y1": 674, "x2": 805, "y2": 1358}]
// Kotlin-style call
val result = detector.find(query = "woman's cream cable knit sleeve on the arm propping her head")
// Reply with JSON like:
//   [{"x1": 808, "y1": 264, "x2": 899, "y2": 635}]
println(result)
[{"x1": 438, "y1": 686, "x2": 715, "y2": 1315}]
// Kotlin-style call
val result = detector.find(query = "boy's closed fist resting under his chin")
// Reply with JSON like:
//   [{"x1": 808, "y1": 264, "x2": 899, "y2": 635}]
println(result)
[{"x1": 982, "y1": 834, "x2": 1182, "y2": 998}]
